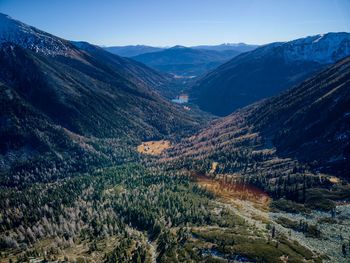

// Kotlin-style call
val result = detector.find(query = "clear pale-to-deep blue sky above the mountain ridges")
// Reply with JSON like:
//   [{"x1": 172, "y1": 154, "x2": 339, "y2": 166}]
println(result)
[{"x1": 0, "y1": 0, "x2": 350, "y2": 46}]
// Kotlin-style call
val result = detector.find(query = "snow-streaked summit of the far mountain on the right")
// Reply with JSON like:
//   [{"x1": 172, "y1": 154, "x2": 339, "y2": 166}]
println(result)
[{"x1": 281, "y1": 33, "x2": 350, "y2": 64}]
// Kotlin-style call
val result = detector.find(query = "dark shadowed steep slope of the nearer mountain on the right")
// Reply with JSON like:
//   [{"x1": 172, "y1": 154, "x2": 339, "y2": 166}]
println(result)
[{"x1": 248, "y1": 57, "x2": 350, "y2": 176}]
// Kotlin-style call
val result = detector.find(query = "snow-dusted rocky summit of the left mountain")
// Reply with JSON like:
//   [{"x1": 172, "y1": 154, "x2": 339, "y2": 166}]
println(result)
[{"x1": 0, "y1": 13, "x2": 72, "y2": 56}]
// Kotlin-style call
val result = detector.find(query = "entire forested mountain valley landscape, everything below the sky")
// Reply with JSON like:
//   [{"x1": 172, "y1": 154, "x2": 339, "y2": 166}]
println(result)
[{"x1": 0, "y1": 11, "x2": 350, "y2": 263}]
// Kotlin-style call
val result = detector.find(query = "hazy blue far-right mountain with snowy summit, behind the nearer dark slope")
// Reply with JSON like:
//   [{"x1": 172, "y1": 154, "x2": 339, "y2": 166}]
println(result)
[{"x1": 191, "y1": 33, "x2": 350, "y2": 116}]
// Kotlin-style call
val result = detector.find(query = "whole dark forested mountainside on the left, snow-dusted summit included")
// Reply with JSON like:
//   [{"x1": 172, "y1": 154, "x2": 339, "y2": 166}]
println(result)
[{"x1": 0, "y1": 15, "x2": 200, "y2": 186}]
